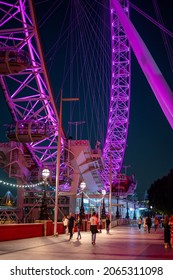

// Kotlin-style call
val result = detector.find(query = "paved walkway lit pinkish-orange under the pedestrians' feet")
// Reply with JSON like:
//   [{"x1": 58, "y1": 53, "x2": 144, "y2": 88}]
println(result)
[{"x1": 0, "y1": 226, "x2": 173, "y2": 260}]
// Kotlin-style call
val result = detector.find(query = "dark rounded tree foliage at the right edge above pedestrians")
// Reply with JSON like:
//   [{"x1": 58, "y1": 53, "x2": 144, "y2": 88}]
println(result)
[{"x1": 148, "y1": 169, "x2": 173, "y2": 215}]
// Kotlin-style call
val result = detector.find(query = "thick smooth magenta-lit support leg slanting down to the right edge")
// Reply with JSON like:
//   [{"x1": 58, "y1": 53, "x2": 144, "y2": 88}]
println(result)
[{"x1": 111, "y1": 0, "x2": 173, "y2": 128}]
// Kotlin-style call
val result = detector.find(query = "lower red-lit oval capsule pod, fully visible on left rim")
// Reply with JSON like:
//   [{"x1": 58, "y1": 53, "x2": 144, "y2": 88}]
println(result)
[{"x1": 6, "y1": 120, "x2": 48, "y2": 143}]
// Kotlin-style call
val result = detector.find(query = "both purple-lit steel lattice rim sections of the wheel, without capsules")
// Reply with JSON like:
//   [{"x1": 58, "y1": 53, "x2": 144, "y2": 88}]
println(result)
[{"x1": 0, "y1": 0, "x2": 130, "y2": 188}]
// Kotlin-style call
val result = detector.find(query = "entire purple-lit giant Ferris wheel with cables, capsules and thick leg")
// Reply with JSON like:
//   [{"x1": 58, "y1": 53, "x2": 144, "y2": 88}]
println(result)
[{"x1": 0, "y1": 0, "x2": 173, "y2": 223}]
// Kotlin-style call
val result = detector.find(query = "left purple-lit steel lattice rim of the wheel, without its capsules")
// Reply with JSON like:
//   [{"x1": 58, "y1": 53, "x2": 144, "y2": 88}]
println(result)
[{"x1": 0, "y1": 0, "x2": 67, "y2": 183}]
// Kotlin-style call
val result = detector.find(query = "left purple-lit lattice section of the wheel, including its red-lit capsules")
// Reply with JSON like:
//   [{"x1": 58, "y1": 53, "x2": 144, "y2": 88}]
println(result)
[{"x1": 0, "y1": 1, "x2": 63, "y2": 184}]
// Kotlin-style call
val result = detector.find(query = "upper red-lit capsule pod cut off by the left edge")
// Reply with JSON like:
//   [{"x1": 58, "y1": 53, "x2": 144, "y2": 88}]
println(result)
[{"x1": 0, "y1": 48, "x2": 31, "y2": 75}]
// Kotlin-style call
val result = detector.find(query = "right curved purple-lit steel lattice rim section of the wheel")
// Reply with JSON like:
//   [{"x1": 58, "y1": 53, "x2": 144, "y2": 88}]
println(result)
[{"x1": 102, "y1": 0, "x2": 130, "y2": 185}]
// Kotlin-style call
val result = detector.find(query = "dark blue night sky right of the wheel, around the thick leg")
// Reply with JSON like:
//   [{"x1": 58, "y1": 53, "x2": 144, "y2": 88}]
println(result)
[{"x1": 122, "y1": 0, "x2": 173, "y2": 199}]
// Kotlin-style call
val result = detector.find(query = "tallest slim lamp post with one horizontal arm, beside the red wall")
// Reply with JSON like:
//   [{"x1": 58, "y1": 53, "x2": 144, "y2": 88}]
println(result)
[{"x1": 54, "y1": 90, "x2": 79, "y2": 236}]
